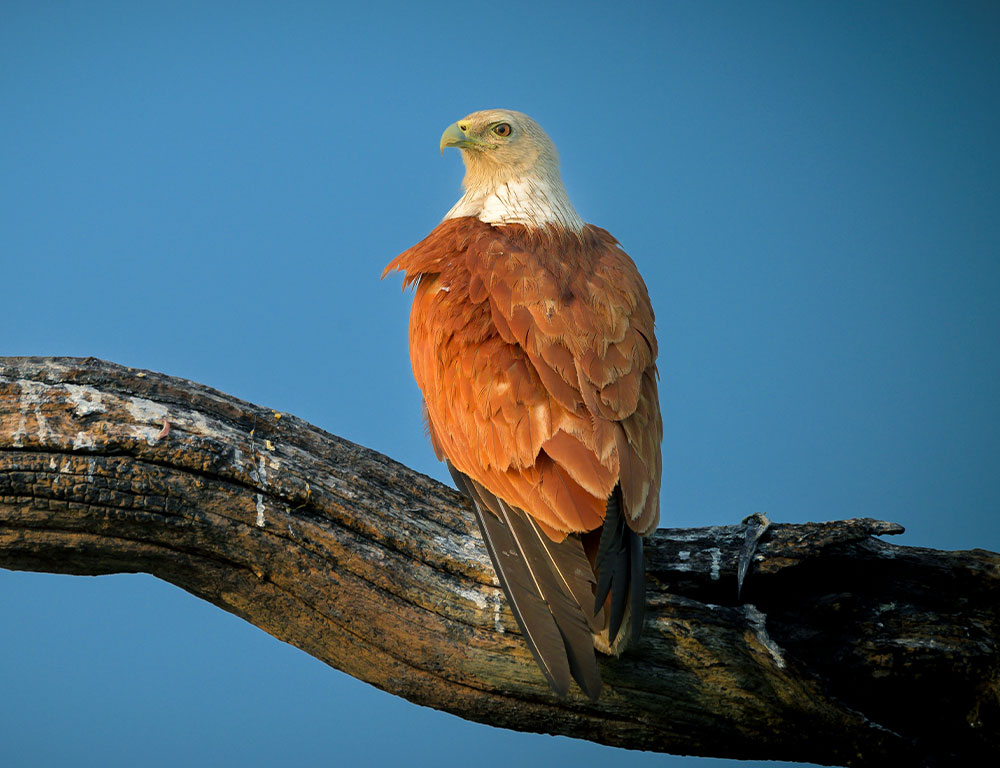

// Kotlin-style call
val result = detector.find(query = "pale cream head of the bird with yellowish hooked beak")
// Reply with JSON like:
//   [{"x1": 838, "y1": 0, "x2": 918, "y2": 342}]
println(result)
[{"x1": 441, "y1": 109, "x2": 559, "y2": 194}]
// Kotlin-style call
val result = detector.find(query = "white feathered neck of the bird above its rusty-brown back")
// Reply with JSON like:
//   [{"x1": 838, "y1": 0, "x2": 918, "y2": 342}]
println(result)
[{"x1": 445, "y1": 176, "x2": 583, "y2": 232}]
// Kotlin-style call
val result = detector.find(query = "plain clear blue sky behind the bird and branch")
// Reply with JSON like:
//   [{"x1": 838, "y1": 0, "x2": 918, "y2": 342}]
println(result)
[{"x1": 0, "y1": 0, "x2": 1000, "y2": 768}]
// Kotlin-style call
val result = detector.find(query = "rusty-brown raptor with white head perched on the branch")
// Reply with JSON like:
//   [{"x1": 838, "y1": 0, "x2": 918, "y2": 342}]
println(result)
[{"x1": 382, "y1": 109, "x2": 663, "y2": 700}]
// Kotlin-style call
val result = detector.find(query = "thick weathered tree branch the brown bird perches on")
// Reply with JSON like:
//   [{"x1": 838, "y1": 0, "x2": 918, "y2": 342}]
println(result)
[{"x1": 0, "y1": 358, "x2": 1000, "y2": 765}]
